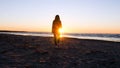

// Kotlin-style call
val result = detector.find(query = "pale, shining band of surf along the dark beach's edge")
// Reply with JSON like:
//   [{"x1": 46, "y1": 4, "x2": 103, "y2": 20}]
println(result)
[{"x1": 0, "y1": 32, "x2": 120, "y2": 42}]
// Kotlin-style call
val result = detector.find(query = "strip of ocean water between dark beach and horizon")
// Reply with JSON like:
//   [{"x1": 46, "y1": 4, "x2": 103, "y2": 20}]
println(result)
[{"x1": 0, "y1": 32, "x2": 120, "y2": 42}]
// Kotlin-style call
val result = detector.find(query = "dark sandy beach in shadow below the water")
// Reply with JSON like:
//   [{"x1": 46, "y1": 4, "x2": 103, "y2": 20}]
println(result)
[{"x1": 0, "y1": 34, "x2": 120, "y2": 68}]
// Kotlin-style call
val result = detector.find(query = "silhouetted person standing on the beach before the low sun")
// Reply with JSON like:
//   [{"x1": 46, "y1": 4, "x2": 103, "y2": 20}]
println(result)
[{"x1": 52, "y1": 15, "x2": 62, "y2": 45}]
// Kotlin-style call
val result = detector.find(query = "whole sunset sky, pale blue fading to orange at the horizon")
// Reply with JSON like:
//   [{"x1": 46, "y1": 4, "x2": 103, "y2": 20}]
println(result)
[{"x1": 0, "y1": 0, "x2": 120, "y2": 34}]
